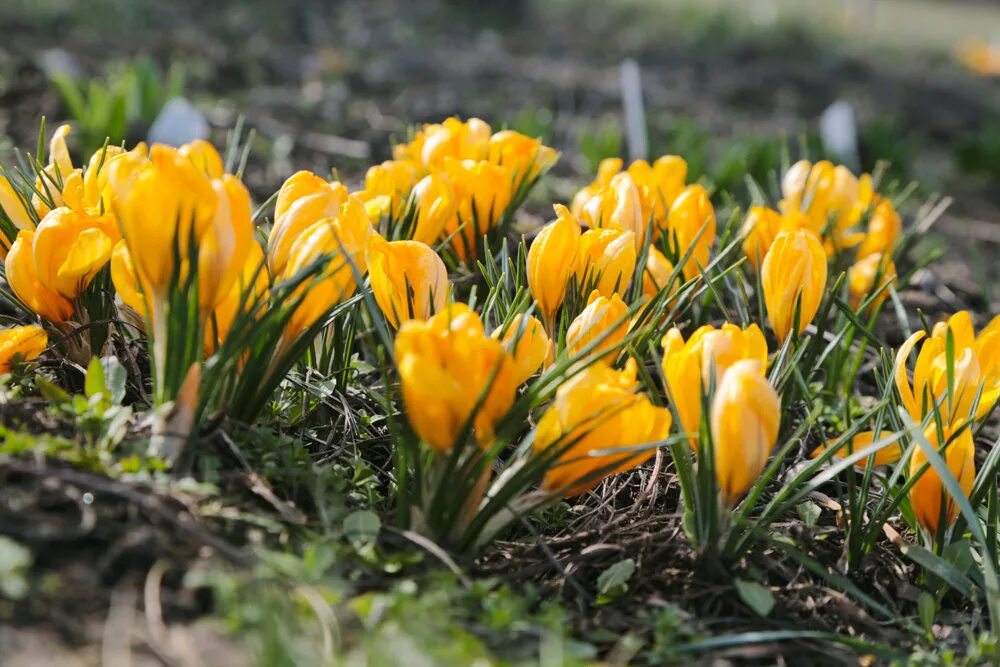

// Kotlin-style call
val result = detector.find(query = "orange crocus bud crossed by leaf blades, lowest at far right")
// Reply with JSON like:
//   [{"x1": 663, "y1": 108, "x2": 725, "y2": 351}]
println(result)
[{"x1": 909, "y1": 424, "x2": 976, "y2": 536}]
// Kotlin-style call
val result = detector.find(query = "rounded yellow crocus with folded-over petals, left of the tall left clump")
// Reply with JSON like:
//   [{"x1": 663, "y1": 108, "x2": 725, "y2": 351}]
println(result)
[{"x1": 32, "y1": 207, "x2": 118, "y2": 300}]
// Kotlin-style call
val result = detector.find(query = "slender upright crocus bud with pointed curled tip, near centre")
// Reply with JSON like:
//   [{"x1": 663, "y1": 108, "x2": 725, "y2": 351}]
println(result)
[{"x1": 528, "y1": 204, "x2": 580, "y2": 333}]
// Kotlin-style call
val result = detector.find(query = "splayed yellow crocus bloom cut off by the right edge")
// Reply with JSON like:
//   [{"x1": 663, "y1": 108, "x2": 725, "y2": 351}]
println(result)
[{"x1": 894, "y1": 310, "x2": 1000, "y2": 424}]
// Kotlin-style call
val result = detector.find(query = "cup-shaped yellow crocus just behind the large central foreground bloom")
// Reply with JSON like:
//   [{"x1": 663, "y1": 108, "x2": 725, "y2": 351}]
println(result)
[{"x1": 367, "y1": 233, "x2": 449, "y2": 329}]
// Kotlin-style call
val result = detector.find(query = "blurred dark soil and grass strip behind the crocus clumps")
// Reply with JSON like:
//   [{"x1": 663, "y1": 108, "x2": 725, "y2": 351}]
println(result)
[{"x1": 0, "y1": 0, "x2": 1000, "y2": 303}]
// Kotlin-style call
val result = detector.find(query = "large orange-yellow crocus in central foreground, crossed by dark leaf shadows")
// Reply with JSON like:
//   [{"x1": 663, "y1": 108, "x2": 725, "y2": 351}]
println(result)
[{"x1": 396, "y1": 308, "x2": 517, "y2": 453}]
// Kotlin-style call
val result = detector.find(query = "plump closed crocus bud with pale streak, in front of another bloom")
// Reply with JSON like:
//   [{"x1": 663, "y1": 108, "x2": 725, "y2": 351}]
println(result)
[{"x1": 711, "y1": 359, "x2": 781, "y2": 507}]
